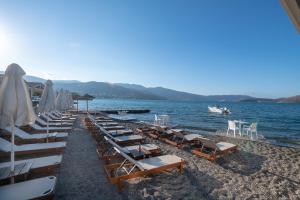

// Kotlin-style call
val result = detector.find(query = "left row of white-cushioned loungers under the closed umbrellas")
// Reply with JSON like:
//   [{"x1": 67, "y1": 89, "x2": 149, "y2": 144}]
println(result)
[{"x1": 0, "y1": 112, "x2": 76, "y2": 200}]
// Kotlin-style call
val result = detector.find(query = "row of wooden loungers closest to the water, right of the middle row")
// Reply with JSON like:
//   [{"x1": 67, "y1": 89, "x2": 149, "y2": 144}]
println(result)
[{"x1": 137, "y1": 126, "x2": 237, "y2": 161}]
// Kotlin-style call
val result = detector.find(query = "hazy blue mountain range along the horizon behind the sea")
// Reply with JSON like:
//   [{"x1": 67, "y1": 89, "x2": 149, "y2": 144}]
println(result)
[{"x1": 0, "y1": 71, "x2": 300, "y2": 103}]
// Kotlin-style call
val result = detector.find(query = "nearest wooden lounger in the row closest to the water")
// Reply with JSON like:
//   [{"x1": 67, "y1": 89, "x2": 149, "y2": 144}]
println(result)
[{"x1": 192, "y1": 138, "x2": 237, "y2": 161}]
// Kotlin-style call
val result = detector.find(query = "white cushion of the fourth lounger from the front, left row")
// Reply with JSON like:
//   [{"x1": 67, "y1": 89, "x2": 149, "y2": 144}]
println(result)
[{"x1": 5, "y1": 127, "x2": 68, "y2": 140}]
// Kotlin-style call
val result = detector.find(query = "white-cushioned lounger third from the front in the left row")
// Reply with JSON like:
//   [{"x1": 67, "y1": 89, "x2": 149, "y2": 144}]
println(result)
[{"x1": 0, "y1": 138, "x2": 66, "y2": 157}]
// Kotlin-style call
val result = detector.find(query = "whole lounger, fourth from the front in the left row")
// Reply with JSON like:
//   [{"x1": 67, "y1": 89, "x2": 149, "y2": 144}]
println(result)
[{"x1": 5, "y1": 127, "x2": 68, "y2": 144}]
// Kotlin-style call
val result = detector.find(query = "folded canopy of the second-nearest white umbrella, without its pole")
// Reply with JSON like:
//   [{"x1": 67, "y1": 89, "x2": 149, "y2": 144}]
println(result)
[{"x1": 38, "y1": 80, "x2": 55, "y2": 113}]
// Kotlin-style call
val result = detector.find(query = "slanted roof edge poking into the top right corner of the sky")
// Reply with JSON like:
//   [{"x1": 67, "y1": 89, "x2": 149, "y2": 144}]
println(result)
[{"x1": 280, "y1": 0, "x2": 300, "y2": 34}]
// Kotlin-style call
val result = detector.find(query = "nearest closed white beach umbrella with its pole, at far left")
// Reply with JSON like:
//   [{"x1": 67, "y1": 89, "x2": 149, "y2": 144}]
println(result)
[{"x1": 0, "y1": 64, "x2": 36, "y2": 178}]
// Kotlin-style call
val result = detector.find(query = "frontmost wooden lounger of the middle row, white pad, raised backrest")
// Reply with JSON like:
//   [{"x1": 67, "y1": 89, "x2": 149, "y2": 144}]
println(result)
[{"x1": 104, "y1": 147, "x2": 184, "y2": 191}]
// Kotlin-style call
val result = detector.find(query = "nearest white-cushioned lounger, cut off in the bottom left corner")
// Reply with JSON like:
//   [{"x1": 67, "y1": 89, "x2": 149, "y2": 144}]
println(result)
[{"x1": 0, "y1": 176, "x2": 56, "y2": 200}]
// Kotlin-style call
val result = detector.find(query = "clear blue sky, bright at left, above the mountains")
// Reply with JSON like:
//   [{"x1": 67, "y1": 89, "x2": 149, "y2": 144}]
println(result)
[{"x1": 0, "y1": 0, "x2": 300, "y2": 98}]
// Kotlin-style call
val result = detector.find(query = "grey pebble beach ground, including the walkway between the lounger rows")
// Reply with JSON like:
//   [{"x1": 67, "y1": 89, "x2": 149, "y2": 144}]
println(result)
[{"x1": 55, "y1": 115, "x2": 300, "y2": 199}]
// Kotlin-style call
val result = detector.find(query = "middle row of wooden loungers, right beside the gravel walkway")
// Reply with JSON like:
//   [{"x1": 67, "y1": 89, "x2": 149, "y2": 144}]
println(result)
[{"x1": 86, "y1": 116, "x2": 185, "y2": 191}]
